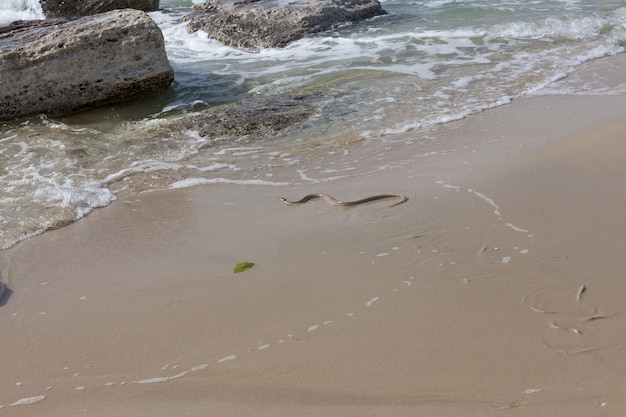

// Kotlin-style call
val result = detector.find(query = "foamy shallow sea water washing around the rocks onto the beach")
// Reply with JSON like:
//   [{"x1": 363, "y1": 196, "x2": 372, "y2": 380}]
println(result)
[{"x1": 0, "y1": 0, "x2": 626, "y2": 248}]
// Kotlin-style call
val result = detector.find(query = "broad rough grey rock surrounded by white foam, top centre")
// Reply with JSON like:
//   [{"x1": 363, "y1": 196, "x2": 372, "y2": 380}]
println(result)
[{"x1": 184, "y1": 0, "x2": 386, "y2": 50}]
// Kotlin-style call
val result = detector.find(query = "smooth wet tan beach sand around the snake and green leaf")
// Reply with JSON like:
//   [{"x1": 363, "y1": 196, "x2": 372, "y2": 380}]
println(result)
[{"x1": 0, "y1": 57, "x2": 626, "y2": 417}]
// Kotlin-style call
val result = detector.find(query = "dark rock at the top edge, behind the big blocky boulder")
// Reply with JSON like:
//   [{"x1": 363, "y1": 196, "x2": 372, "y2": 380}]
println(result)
[{"x1": 40, "y1": 0, "x2": 159, "y2": 17}]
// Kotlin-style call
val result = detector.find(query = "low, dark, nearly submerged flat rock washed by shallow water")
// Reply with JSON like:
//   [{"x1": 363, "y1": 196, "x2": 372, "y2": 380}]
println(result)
[{"x1": 150, "y1": 93, "x2": 322, "y2": 143}]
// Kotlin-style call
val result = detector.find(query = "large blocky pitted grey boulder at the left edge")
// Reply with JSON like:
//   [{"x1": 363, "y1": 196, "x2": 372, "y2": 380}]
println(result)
[{"x1": 0, "y1": 9, "x2": 174, "y2": 120}]
